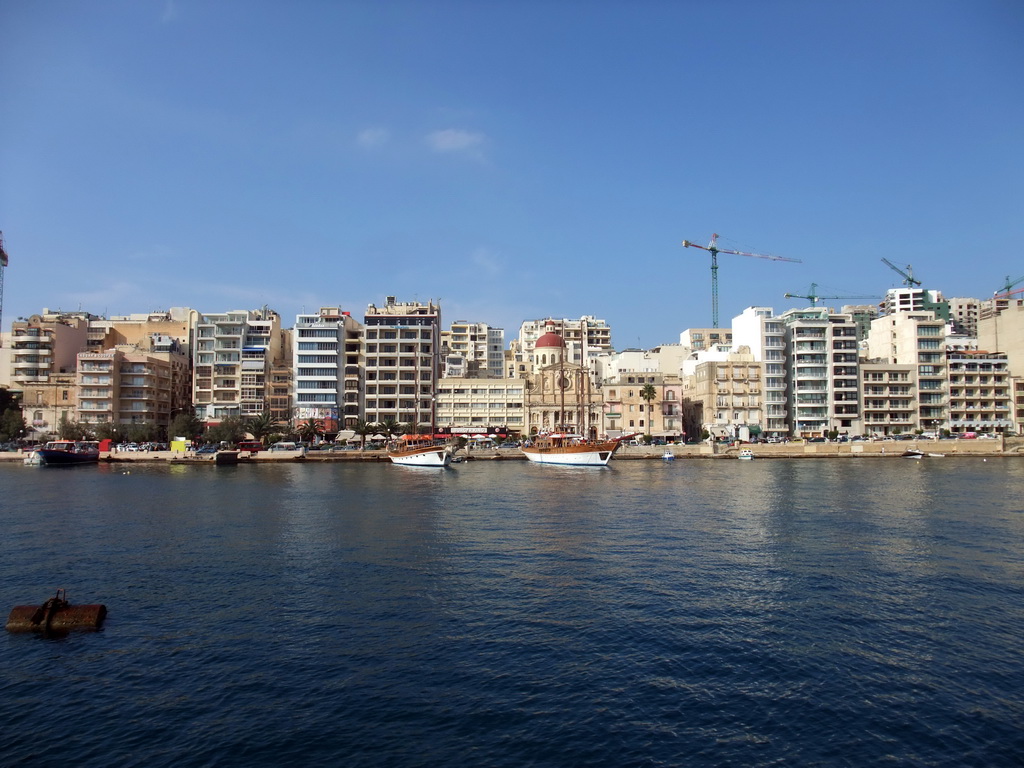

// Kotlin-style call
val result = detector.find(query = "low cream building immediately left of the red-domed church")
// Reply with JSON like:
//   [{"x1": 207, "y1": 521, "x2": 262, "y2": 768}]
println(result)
[{"x1": 434, "y1": 376, "x2": 526, "y2": 434}]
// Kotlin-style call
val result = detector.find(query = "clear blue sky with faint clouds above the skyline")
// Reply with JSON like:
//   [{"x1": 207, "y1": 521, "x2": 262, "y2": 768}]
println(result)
[{"x1": 0, "y1": 0, "x2": 1024, "y2": 348}]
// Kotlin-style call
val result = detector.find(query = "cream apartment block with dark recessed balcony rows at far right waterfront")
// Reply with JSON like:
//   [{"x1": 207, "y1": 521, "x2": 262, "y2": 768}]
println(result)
[{"x1": 946, "y1": 351, "x2": 1016, "y2": 434}]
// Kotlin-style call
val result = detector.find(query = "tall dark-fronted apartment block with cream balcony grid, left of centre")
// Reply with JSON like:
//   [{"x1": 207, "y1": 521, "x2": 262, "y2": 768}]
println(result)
[{"x1": 362, "y1": 296, "x2": 441, "y2": 426}]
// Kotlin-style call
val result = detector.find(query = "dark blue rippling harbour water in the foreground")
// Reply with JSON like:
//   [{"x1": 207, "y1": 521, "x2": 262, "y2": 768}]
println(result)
[{"x1": 0, "y1": 459, "x2": 1024, "y2": 767}]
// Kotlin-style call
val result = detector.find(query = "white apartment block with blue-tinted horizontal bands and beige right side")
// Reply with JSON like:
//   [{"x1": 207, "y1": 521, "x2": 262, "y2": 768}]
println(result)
[{"x1": 292, "y1": 307, "x2": 362, "y2": 432}]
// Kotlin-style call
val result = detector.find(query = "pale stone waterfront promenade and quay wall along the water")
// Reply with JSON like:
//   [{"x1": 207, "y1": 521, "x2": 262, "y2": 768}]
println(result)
[{"x1": 0, "y1": 437, "x2": 1024, "y2": 465}]
